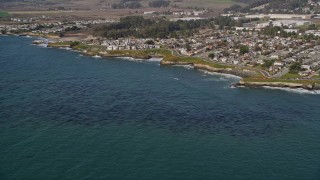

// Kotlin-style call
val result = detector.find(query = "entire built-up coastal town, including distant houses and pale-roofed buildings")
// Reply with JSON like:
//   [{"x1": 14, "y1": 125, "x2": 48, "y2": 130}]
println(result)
[{"x1": 0, "y1": 11, "x2": 320, "y2": 77}]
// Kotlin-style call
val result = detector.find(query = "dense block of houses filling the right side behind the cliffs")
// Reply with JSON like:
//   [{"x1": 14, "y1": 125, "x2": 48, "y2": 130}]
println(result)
[{"x1": 162, "y1": 26, "x2": 320, "y2": 74}]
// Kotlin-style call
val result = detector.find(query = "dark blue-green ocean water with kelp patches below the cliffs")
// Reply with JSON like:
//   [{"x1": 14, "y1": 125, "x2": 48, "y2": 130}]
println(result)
[{"x1": 0, "y1": 37, "x2": 320, "y2": 180}]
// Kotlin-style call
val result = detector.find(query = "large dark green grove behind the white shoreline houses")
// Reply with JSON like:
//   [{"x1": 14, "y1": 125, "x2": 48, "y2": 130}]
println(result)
[{"x1": 94, "y1": 16, "x2": 213, "y2": 39}]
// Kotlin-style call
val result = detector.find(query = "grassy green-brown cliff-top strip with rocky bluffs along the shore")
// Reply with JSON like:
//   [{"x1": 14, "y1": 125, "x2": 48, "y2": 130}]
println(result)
[{"x1": 11, "y1": 33, "x2": 320, "y2": 91}]
